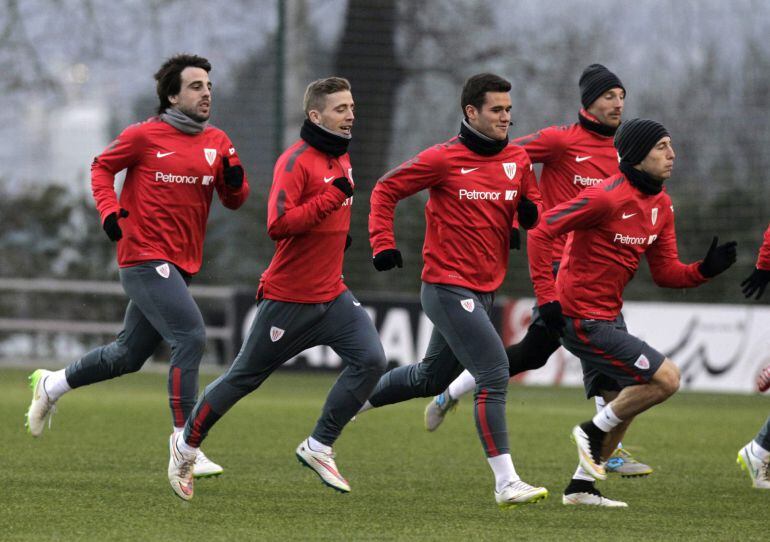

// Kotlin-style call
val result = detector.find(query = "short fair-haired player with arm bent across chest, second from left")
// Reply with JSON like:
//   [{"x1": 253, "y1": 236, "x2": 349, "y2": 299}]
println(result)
[{"x1": 168, "y1": 77, "x2": 385, "y2": 500}]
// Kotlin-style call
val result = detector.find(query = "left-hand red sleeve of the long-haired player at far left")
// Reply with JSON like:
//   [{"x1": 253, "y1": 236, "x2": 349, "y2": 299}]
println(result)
[{"x1": 91, "y1": 124, "x2": 144, "y2": 223}]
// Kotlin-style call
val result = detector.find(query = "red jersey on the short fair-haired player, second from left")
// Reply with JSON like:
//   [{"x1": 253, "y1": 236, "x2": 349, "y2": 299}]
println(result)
[{"x1": 259, "y1": 139, "x2": 353, "y2": 303}]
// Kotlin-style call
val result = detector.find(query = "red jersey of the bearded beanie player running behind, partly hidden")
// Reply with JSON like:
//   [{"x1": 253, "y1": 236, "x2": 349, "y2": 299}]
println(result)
[{"x1": 513, "y1": 122, "x2": 619, "y2": 262}]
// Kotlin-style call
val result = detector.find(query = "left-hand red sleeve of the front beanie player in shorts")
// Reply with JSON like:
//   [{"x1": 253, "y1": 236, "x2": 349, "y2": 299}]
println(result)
[{"x1": 527, "y1": 186, "x2": 613, "y2": 305}]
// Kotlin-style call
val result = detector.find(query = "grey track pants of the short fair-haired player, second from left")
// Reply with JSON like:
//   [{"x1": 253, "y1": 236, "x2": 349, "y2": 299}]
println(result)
[{"x1": 185, "y1": 291, "x2": 385, "y2": 446}]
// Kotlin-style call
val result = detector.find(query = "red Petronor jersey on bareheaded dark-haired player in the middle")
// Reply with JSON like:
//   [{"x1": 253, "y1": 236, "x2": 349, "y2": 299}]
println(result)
[{"x1": 369, "y1": 137, "x2": 542, "y2": 292}]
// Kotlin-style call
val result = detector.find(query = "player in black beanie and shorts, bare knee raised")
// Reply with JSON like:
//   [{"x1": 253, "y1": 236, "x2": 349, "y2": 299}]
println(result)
[{"x1": 529, "y1": 119, "x2": 736, "y2": 507}]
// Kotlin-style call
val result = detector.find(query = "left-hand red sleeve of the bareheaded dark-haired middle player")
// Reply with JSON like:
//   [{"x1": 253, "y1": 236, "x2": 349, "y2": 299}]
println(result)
[{"x1": 369, "y1": 146, "x2": 448, "y2": 254}]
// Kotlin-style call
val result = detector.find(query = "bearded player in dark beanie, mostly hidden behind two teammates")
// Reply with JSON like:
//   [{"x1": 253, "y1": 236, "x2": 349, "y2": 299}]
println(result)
[{"x1": 425, "y1": 64, "x2": 652, "y2": 477}]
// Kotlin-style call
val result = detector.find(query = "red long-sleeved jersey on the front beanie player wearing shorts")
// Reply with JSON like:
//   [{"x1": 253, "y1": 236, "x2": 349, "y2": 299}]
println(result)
[{"x1": 529, "y1": 174, "x2": 706, "y2": 320}]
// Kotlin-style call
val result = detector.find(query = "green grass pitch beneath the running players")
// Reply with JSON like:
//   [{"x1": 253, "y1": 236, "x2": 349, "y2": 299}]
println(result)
[{"x1": 0, "y1": 369, "x2": 770, "y2": 541}]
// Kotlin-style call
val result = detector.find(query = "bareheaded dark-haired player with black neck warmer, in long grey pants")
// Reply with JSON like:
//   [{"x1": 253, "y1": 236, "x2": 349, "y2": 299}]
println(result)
[{"x1": 364, "y1": 73, "x2": 548, "y2": 508}]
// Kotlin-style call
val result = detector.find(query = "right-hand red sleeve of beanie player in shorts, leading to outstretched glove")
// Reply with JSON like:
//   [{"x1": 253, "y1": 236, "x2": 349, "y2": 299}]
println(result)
[{"x1": 645, "y1": 208, "x2": 707, "y2": 288}]
